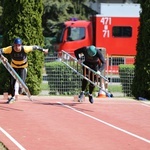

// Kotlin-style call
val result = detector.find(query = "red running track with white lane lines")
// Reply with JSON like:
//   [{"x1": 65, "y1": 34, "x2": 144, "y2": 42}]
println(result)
[{"x1": 0, "y1": 96, "x2": 150, "y2": 150}]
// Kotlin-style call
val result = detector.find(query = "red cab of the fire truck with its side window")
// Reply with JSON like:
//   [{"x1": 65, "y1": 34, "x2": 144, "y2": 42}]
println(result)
[{"x1": 54, "y1": 20, "x2": 93, "y2": 56}]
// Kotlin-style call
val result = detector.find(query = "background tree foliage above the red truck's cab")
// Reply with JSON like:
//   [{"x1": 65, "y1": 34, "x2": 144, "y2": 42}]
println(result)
[{"x1": 43, "y1": 0, "x2": 96, "y2": 36}]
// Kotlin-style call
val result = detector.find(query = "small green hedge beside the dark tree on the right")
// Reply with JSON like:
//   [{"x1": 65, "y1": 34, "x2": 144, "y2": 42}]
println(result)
[{"x1": 119, "y1": 64, "x2": 134, "y2": 96}]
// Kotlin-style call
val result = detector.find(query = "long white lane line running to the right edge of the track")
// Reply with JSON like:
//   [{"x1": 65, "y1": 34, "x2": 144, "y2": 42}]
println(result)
[{"x1": 57, "y1": 102, "x2": 150, "y2": 143}]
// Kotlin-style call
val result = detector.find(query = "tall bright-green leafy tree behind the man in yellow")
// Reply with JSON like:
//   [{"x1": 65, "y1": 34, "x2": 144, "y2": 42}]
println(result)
[{"x1": 0, "y1": 0, "x2": 44, "y2": 95}]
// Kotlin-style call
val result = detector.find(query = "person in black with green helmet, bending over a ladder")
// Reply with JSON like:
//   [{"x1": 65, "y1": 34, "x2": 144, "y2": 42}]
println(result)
[{"x1": 74, "y1": 45, "x2": 106, "y2": 103}]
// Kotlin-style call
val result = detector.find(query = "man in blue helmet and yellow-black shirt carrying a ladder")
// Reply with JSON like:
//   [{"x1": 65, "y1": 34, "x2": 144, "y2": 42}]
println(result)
[{"x1": 0, "y1": 38, "x2": 48, "y2": 103}]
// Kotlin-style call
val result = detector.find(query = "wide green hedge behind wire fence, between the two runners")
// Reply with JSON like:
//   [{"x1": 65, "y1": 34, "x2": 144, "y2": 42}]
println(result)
[{"x1": 45, "y1": 61, "x2": 81, "y2": 95}]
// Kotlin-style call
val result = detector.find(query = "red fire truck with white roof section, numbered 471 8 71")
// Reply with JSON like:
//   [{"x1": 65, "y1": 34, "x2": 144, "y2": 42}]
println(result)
[{"x1": 51, "y1": 4, "x2": 140, "y2": 73}]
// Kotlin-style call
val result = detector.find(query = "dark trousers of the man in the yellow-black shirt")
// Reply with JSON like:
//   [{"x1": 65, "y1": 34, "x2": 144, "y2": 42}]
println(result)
[{"x1": 10, "y1": 68, "x2": 27, "y2": 97}]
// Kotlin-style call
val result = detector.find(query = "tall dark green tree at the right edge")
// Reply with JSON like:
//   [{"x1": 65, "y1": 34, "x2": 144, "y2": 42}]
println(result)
[{"x1": 132, "y1": 0, "x2": 150, "y2": 99}]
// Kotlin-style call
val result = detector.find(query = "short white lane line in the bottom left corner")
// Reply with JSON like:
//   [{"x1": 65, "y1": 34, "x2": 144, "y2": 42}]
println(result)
[{"x1": 0, "y1": 127, "x2": 26, "y2": 150}]
